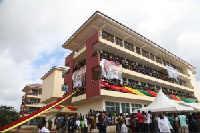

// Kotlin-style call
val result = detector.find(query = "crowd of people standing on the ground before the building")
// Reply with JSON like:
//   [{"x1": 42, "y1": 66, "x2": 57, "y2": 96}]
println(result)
[{"x1": 38, "y1": 110, "x2": 200, "y2": 133}]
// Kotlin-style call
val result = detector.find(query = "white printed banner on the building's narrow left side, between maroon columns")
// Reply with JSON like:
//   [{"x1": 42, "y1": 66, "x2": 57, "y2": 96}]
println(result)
[{"x1": 72, "y1": 66, "x2": 86, "y2": 87}]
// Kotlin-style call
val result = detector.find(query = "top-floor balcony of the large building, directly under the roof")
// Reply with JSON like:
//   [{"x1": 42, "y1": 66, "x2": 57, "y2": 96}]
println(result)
[{"x1": 98, "y1": 31, "x2": 190, "y2": 79}]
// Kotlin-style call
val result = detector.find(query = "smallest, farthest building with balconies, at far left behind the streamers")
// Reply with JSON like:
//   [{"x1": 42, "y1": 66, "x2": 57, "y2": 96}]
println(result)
[{"x1": 20, "y1": 84, "x2": 46, "y2": 128}]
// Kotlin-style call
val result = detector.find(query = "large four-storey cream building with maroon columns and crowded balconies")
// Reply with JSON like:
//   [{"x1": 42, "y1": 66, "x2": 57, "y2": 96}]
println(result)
[{"x1": 63, "y1": 12, "x2": 197, "y2": 114}]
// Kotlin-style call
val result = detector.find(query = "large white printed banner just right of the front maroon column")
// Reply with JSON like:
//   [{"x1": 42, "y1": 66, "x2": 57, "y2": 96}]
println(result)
[{"x1": 102, "y1": 59, "x2": 122, "y2": 82}]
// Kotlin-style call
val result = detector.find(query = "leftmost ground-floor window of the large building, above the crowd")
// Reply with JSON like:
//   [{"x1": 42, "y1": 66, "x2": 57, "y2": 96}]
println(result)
[{"x1": 105, "y1": 101, "x2": 120, "y2": 114}]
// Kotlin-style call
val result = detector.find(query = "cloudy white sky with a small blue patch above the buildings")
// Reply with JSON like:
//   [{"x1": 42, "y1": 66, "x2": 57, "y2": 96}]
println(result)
[{"x1": 0, "y1": 0, "x2": 200, "y2": 111}]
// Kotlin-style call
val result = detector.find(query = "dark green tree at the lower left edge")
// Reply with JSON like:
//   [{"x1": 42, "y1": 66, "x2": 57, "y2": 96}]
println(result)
[{"x1": 0, "y1": 106, "x2": 19, "y2": 127}]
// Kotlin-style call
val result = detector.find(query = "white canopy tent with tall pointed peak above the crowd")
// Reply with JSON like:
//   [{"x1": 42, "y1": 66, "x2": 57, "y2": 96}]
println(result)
[{"x1": 134, "y1": 90, "x2": 194, "y2": 112}]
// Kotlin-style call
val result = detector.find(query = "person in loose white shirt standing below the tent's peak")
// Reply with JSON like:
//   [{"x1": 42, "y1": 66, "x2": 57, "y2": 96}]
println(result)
[{"x1": 158, "y1": 114, "x2": 172, "y2": 133}]
